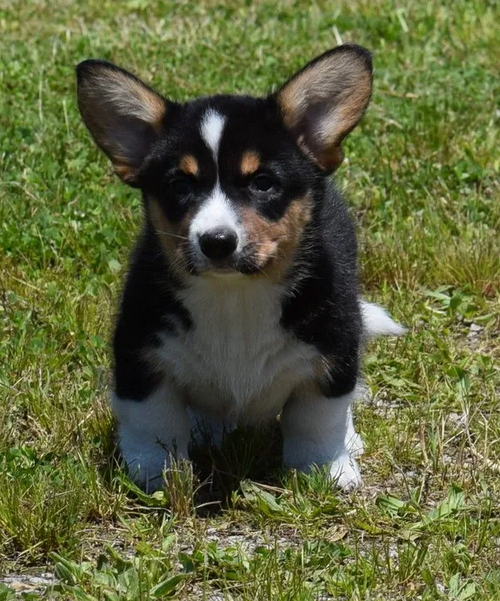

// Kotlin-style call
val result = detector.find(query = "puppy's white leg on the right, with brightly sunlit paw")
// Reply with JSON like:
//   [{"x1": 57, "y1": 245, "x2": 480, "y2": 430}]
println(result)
[{"x1": 281, "y1": 386, "x2": 361, "y2": 490}]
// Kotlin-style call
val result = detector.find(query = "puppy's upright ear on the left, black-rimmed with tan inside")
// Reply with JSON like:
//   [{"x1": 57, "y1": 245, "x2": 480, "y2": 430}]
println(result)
[{"x1": 76, "y1": 60, "x2": 173, "y2": 186}]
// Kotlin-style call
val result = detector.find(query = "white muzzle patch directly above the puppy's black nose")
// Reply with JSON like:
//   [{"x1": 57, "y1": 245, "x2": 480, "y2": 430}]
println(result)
[{"x1": 189, "y1": 183, "x2": 243, "y2": 246}]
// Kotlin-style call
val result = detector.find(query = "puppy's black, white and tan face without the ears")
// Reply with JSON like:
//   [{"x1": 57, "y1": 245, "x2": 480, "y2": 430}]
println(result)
[{"x1": 140, "y1": 97, "x2": 314, "y2": 277}]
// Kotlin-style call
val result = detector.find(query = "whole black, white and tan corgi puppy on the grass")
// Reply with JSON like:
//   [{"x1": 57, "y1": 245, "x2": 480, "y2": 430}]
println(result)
[{"x1": 77, "y1": 44, "x2": 402, "y2": 491}]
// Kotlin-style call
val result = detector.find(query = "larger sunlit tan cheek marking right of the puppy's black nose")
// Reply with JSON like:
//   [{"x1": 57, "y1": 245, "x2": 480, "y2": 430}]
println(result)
[{"x1": 242, "y1": 196, "x2": 312, "y2": 281}]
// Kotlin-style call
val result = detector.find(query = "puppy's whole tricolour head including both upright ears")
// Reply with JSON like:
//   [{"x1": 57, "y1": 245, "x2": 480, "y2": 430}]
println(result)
[{"x1": 77, "y1": 45, "x2": 372, "y2": 279}]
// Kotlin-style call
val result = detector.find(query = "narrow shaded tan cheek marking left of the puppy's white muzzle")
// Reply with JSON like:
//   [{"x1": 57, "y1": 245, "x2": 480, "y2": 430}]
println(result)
[{"x1": 148, "y1": 197, "x2": 192, "y2": 273}]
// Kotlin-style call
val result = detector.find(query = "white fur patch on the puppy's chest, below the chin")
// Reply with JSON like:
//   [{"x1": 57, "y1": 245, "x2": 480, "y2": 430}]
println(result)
[{"x1": 152, "y1": 278, "x2": 317, "y2": 423}]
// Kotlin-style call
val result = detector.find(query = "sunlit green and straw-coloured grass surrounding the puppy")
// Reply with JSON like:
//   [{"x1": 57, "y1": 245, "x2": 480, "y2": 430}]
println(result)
[{"x1": 0, "y1": 0, "x2": 500, "y2": 601}]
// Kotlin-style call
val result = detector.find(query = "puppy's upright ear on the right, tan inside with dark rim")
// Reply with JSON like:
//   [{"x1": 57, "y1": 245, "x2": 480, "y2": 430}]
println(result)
[{"x1": 275, "y1": 44, "x2": 372, "y2": 172}]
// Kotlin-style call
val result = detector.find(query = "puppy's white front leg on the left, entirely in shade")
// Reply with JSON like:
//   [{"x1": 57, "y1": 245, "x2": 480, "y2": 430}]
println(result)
[{"x1": 112, "y1": 381, "x2": 190, "y2": 492}]
